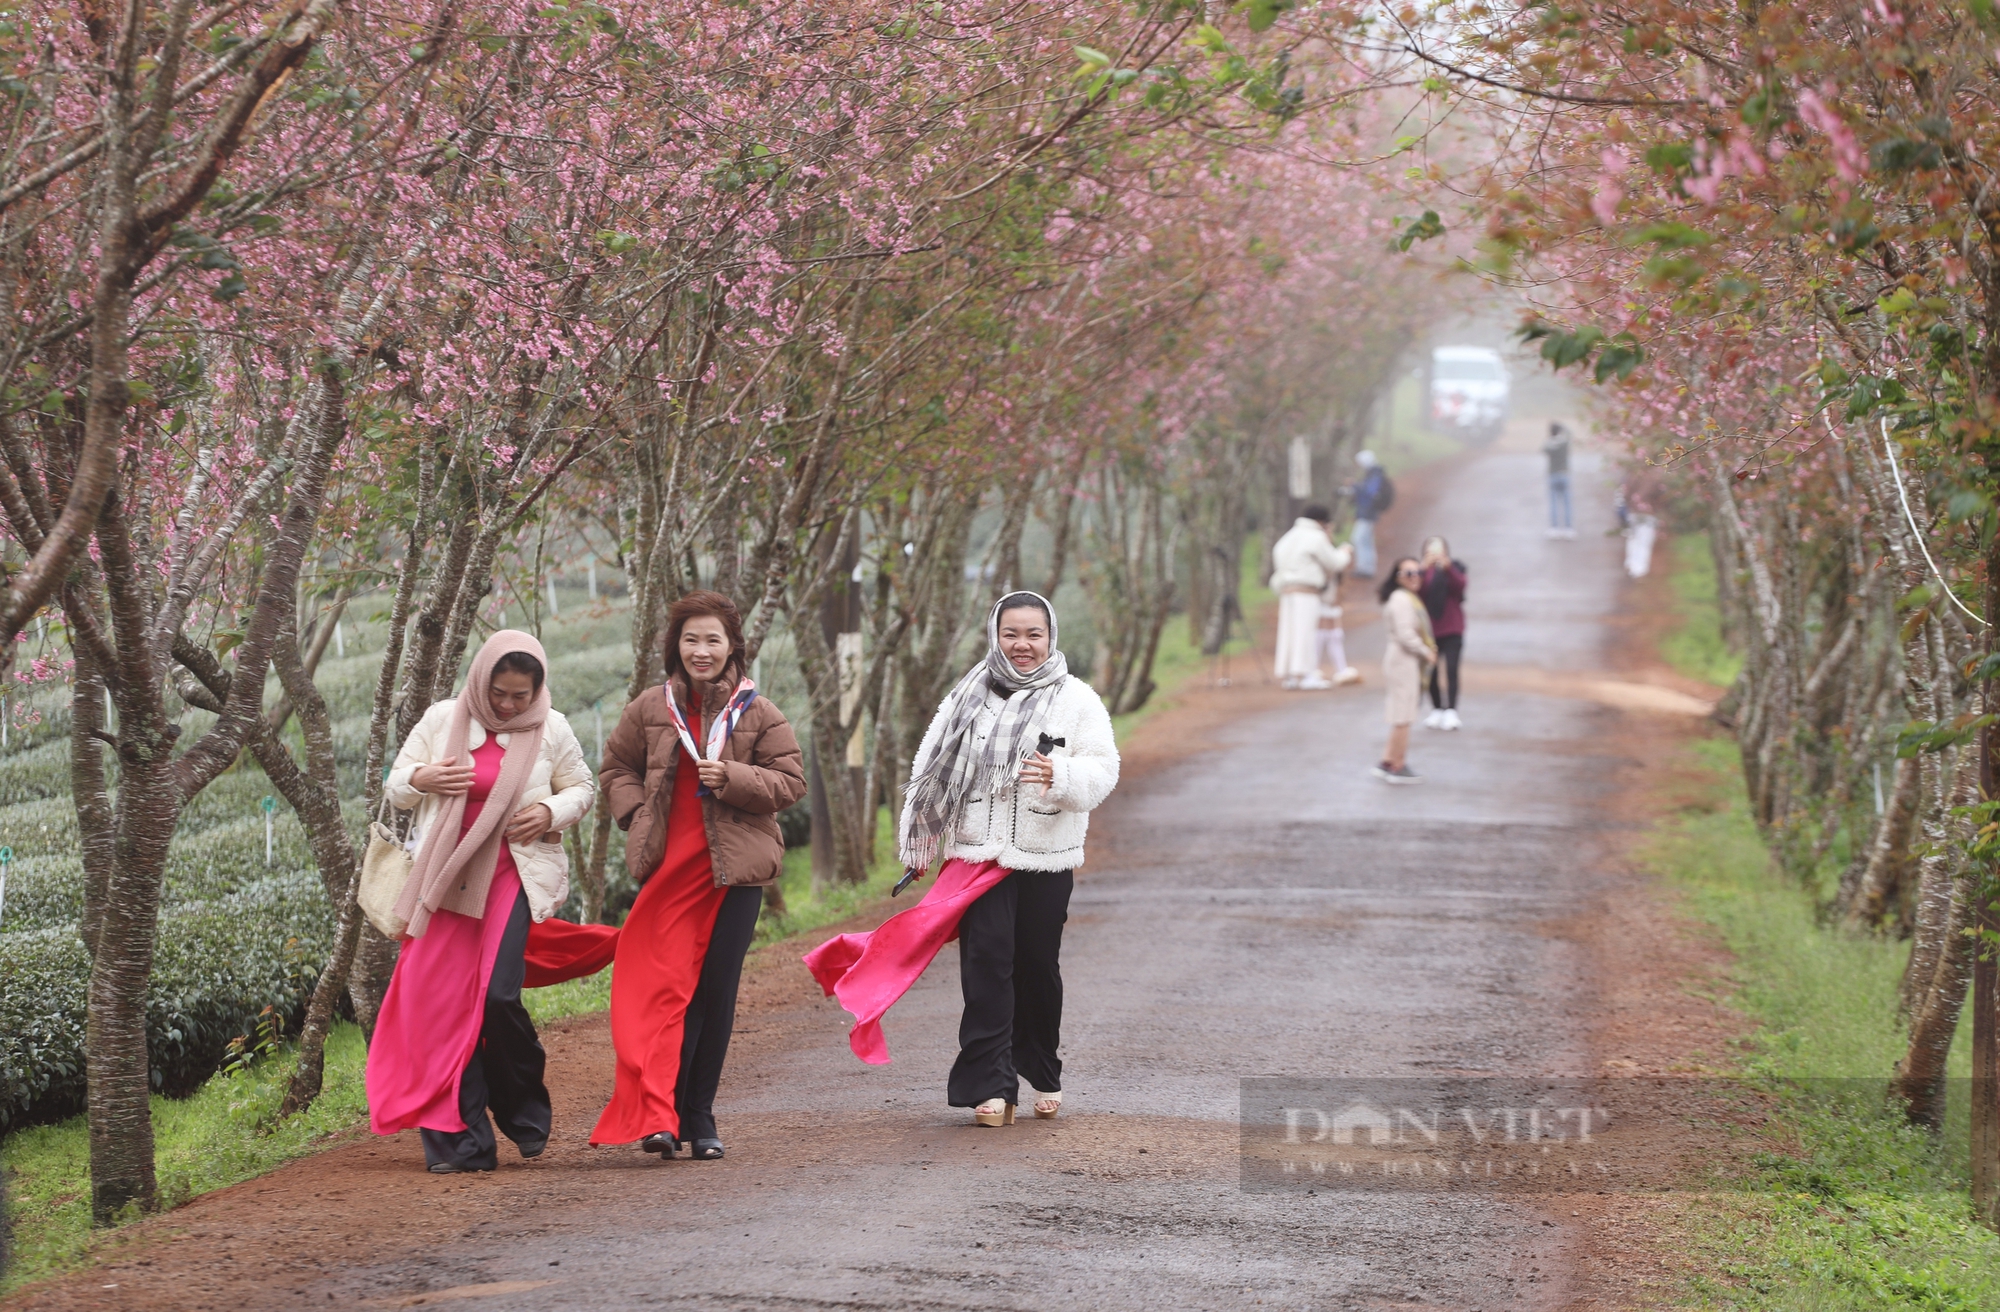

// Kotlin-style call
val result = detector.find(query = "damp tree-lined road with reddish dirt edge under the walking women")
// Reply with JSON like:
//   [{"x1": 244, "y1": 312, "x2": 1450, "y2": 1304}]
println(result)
[{"x1": 7, "y1": 450, "x2": 1720, "y2": 1312}]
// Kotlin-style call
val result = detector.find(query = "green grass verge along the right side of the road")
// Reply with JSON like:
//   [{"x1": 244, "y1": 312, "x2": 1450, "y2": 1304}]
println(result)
[{"x1": 1640, "y1": 538, "x2": 2000, "y2": 1312}]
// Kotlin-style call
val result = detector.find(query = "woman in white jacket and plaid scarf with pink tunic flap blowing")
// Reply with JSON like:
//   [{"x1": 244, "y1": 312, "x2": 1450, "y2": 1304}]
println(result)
[{"x1": 806, "y1": 592, "x2": 1118, "y2": 1126}]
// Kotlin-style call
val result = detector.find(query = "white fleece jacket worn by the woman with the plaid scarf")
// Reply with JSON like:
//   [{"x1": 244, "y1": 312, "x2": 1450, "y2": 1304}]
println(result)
[{"x1": 904, "y1": 674, "x2": 1118, "y2": 870}]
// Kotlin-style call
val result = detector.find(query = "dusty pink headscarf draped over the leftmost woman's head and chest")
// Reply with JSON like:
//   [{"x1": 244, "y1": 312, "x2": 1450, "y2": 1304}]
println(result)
[{"x1": 396, "y1": 628, "x2": 548, "y2": 938}]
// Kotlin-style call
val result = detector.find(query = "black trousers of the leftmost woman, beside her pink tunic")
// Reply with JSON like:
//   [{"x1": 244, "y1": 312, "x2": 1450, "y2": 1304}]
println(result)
[{"x1": 422, "y1": 892, "x2": 552, "y2": 1170}]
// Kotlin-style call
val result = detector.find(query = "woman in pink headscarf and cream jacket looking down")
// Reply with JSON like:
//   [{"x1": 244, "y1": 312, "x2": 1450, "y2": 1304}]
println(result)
[{"x1": 368, "y1": 630, "x2": 596, "y2": 1172}]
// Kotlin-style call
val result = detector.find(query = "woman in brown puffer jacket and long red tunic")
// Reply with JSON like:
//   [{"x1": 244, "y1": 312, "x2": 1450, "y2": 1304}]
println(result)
[{"x1": 590, "y1": 592, "x2": 806, "y2": 1160}]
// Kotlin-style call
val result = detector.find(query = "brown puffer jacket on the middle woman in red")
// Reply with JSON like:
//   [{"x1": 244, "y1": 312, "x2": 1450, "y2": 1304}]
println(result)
[{"x1": 598, "y1": 678, "x2": 806, "y2": 888}]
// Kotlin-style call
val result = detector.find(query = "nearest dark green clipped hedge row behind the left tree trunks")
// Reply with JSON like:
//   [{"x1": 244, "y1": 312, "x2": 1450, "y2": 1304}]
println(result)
[{"x1": 0, "y1": 872, "x2": 332, "y2": 1132}]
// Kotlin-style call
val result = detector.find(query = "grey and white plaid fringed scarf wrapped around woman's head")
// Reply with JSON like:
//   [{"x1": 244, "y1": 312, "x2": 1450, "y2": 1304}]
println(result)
[{"x1": 900, "y1": 592, "x2": 1070, "y2": 870}]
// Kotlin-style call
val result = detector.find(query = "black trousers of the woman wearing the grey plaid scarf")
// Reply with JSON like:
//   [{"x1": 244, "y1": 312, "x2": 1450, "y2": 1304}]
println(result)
[{"x1": 946, "y1": 870, "x2": 1076, "y2": 1106}]
